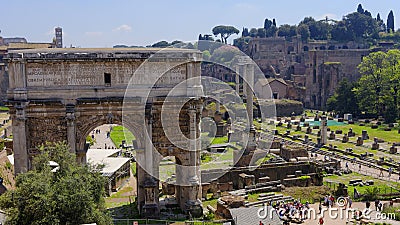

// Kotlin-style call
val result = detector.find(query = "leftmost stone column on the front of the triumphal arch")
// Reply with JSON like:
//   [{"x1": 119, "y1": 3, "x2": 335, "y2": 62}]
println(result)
[{"x1": 12, "y1": 103, "x2": 29, "y2": 175}]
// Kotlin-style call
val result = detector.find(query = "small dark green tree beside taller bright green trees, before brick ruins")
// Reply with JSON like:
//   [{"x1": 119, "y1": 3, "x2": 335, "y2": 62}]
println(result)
[{"x1": 327, "y1": 78, "x2": 358, "y2": 115}]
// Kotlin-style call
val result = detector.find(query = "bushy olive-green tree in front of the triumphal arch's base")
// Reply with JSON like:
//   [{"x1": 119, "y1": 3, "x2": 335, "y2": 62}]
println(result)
[{"x1": 0, "y1": 143, "x2": 111, "y2": 225}]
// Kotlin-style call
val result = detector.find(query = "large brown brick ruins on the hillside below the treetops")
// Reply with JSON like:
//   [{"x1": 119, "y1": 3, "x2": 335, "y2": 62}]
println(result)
[{"x1": 241, "y1": 37, "x2": 370, "y2": 109}]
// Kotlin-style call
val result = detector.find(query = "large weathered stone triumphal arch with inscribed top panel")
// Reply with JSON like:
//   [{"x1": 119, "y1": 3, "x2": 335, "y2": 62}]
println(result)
[{"x1": 7, "y1": 48, "x2": 202, "y2": 217}]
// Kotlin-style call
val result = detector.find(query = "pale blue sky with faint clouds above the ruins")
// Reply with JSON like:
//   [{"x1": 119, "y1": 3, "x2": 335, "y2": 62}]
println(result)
[{"x1": 0, "y1": 0, "x2": 400, "y2": 47}]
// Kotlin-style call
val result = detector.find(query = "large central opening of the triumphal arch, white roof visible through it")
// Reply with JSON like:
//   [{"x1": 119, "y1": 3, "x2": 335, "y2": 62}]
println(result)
[{"x1": 86, "y1": 124, "x2": 137, "y2": 196}]
